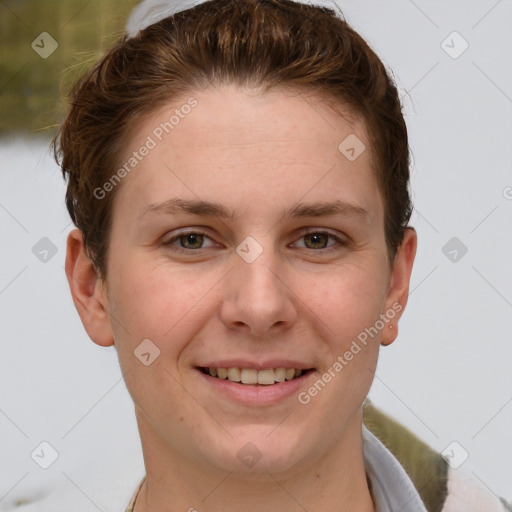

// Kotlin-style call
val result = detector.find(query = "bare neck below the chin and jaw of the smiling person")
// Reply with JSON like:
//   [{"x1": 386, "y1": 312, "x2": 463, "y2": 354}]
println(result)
[{"x1": 134, "y1": 414, "x2": 375, "y2": 512}]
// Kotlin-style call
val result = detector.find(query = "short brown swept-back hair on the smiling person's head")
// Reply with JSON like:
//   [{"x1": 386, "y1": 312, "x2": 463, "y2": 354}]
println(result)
[{"x1": 53, "y1": 0, "x2": 412, "y2": 278}]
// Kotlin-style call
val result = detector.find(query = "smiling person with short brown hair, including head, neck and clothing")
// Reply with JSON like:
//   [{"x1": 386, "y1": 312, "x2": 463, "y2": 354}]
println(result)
[{"x1": 55, "y1": 0, "x2": 506, "y2": 512}]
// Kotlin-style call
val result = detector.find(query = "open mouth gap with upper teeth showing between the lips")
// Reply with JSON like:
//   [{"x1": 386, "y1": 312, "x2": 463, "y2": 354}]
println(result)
[{"x1": 197, "y1": 366, "x2": 314, "y2": 387}]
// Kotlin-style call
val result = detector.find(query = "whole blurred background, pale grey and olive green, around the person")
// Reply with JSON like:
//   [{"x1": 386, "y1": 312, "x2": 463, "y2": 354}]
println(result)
[{"x1": 0, "y1": 0, "x2": 512, "y2": 512}]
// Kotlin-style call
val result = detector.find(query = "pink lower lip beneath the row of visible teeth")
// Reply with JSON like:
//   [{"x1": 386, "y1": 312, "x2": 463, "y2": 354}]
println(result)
[{"x1": 196, "y1": 370, "x2": 315, "y2": 406}]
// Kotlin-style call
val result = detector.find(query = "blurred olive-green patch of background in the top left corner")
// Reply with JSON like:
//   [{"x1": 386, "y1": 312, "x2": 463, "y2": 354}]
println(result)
[{"x1": 0, "y1": 0, "x2": 137, "y2": 137}]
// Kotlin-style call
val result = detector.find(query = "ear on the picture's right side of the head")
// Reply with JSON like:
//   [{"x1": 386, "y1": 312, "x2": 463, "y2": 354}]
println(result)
[{"x1": 380, "y1": 228, "x2": 418, "y2": 345}]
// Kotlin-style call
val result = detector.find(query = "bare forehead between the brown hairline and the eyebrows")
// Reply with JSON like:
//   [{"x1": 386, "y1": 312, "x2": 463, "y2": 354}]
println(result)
[{"x1": 113, "y1": 85, "x2": 377, "y2": 220}]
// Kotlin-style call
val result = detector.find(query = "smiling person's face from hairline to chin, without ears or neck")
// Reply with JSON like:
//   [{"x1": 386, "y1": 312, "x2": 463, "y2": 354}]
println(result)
[{"x1": 83, "y1": 86, "x2": 412, "y2": 472}]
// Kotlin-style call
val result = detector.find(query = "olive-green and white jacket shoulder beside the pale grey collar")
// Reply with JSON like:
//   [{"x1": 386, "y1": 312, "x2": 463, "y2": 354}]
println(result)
[{"x1": 363, "y1": 401, "x2": 512, "y2": 512}]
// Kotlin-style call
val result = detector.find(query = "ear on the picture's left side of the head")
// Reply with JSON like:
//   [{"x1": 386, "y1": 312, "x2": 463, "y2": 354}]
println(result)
[{"x1": 66, "y1": 229, "x2": 114, "y2": 347}]
